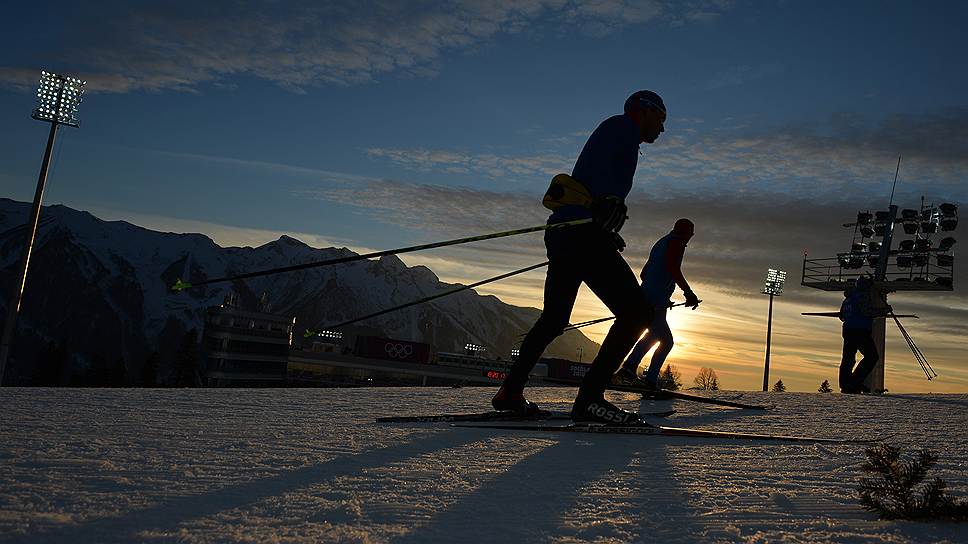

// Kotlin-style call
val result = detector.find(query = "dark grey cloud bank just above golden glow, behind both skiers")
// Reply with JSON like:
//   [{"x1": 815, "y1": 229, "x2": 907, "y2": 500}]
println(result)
[{"x1": 302, "y1": 176, "x2": 968, "y2": 304}]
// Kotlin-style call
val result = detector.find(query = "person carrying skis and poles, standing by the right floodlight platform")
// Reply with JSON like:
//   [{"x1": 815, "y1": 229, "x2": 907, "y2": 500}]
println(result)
[{"x1": 840, "y1": 276, "x2": 892, "y2": 394}]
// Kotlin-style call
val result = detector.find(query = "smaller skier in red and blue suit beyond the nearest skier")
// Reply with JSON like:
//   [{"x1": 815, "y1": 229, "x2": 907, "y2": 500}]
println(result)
[{"x1": 615, "y1": 219, "x2": 700, "y2": 389}]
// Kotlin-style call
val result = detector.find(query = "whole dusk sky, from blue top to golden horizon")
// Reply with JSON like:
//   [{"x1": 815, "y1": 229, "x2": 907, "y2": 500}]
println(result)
[{"x1": 0, "y1": 0, "x2": 968, "y2": 392}]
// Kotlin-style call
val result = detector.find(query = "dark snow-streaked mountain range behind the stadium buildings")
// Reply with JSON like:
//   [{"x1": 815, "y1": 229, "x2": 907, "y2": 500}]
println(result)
[{"x1": 0, "y1": 199, "x2": 599, "y2": 383}]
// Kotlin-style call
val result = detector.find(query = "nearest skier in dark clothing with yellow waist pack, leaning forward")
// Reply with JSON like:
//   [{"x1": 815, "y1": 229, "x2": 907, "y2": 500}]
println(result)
[{"x1": 491, "y1": 91, "x2": 666, "y2": 424}]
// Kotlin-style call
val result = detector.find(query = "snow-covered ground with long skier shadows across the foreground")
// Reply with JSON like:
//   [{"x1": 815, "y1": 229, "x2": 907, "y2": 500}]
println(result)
[{"x1": 0, "y1": 388, "x2": 968, "y2": 542}]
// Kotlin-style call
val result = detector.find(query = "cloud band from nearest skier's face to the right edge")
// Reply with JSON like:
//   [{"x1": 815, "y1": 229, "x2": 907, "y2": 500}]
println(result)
[{"x1": 637, "y1": 113, "x2": 968, "y2": 204}]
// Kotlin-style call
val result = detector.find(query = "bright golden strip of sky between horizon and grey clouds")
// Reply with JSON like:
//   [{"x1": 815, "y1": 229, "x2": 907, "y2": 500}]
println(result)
[{"x1": 466, "y1": 274, "x2": 968, "y2": 393}]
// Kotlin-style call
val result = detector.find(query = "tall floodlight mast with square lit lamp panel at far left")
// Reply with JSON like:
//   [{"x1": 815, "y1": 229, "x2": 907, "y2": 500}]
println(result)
[{"x1": 0, "y1": 72, "x2": 85, "y2": 382}]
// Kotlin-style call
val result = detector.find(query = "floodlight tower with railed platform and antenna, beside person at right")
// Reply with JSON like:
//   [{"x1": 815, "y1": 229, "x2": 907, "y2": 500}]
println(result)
[{"x1": 801, "y1": 158, "x2": 958, "y2": 393}]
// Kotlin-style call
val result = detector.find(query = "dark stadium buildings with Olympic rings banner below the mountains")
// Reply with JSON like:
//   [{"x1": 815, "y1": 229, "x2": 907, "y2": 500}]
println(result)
[{"x1": 202, "y1": 295, "x2": 568, "y2": 387}]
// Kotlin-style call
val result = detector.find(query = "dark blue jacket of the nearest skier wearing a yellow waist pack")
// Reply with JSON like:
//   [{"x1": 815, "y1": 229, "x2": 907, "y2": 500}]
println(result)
[{"x1": 548, "y1": 114, "x2": 641, "y2": 223}]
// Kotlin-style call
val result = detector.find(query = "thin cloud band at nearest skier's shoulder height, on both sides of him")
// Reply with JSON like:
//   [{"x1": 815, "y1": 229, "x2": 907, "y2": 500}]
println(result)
[{"x1": 356, "y1": 108, "x2": 968, "y2": 202}]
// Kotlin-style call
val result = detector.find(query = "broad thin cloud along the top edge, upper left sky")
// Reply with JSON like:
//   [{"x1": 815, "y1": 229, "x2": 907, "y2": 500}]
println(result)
[{"x1": 0, "y1": 0, "x2": 728, "y2": 93}]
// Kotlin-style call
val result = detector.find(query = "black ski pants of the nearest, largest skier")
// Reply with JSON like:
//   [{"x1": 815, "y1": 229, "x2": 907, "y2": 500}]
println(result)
[{"x1": 504, "y1": 225, "x2": 653, "y2": 398}]
